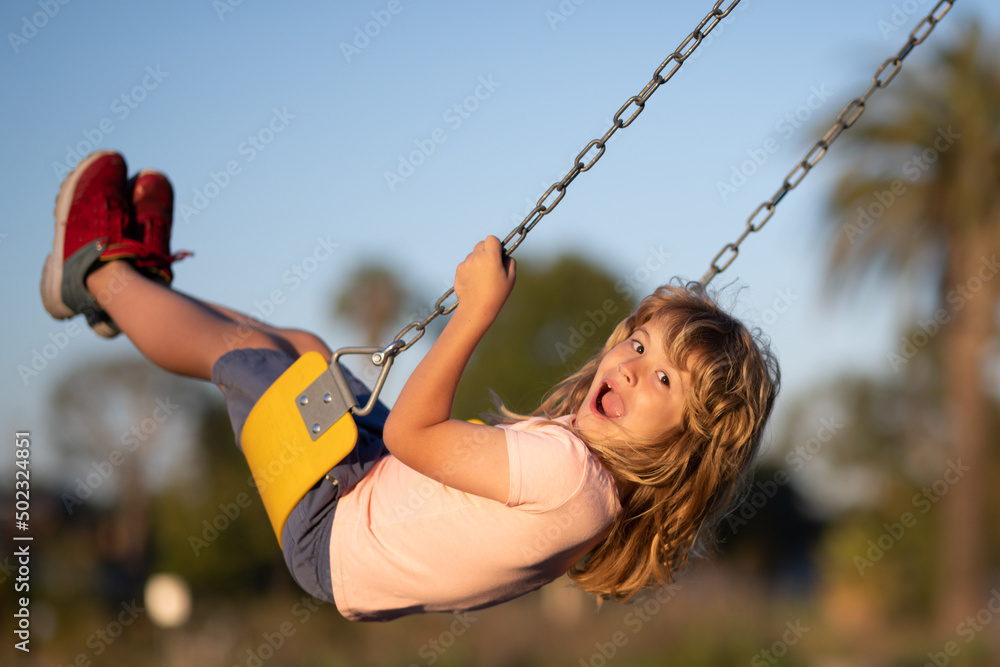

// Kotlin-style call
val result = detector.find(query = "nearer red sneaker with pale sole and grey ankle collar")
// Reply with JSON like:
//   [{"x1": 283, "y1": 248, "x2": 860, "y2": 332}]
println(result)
[{"x1": 41, "y1": 151, "x2": 143, "y2": 338}]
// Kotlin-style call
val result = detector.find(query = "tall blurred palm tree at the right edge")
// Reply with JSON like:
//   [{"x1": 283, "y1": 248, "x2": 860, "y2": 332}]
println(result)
[{"x1": 830, "y1": 18, "x2": 1000, "y2": 630}]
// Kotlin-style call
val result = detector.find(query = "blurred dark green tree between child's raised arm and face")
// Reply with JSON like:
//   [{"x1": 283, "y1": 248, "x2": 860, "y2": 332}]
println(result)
[{"x1": 453, "y1": 255, "x2": 635, "y2": 418}]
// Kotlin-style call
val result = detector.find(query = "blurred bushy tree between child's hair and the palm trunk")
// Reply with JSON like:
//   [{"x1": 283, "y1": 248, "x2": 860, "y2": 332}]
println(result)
[{"x1": 778, "y1": 376, "x2": 954, "y2": 616}]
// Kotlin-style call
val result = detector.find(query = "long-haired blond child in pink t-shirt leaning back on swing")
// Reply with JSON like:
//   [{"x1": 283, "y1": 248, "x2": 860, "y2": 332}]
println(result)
[{"x1": 42, "y1": 151, "x2": 778, "y2": 620}]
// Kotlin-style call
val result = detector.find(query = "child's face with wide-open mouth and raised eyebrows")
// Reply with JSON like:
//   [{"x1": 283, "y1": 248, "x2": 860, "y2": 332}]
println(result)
[{"x1": 576, "y1": 320, "x2": 691, "y2": 440}]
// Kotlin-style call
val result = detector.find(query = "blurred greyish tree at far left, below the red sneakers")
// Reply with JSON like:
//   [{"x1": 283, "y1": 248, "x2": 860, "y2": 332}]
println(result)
[{"x1": 50, "y1": 360, "x2": 209, "y2": 604}]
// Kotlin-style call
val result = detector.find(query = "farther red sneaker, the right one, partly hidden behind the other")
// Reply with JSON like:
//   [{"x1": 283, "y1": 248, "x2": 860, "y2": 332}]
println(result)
[{"x1": 128, "y1": 169, "x2": 191, "y2": 285}]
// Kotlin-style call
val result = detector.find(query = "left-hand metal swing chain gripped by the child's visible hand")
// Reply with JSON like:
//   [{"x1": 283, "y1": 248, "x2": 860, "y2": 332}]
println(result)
[{"x1": 372, "y1": 0, "x2": 740, "y2": 366}]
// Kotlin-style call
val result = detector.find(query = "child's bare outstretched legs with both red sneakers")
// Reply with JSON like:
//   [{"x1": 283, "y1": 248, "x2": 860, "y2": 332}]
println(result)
[{"x1": 41, "y1": 151, "x2": 330, "y2": 380}]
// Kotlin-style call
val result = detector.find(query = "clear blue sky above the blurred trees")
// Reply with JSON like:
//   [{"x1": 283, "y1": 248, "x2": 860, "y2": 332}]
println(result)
[{"x1": 0, "y1": 0, "x2": 1000, "y2": 486}]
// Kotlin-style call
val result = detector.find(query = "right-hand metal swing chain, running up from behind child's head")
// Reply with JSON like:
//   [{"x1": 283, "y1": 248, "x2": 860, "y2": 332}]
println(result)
[{"x1": 699, "y1": 0, "x2": 955, "y2": 285}]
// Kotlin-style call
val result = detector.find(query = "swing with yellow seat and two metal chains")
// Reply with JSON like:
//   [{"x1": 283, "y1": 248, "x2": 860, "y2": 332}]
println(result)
[{"x1": 242, "y1": 0, "x2": 954, "y2": 543}]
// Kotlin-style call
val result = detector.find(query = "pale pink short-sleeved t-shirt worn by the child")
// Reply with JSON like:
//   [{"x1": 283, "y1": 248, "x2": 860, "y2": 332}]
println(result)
[{"x1": 330, "y1": 417, "x2": 621, "y2": 620}]
